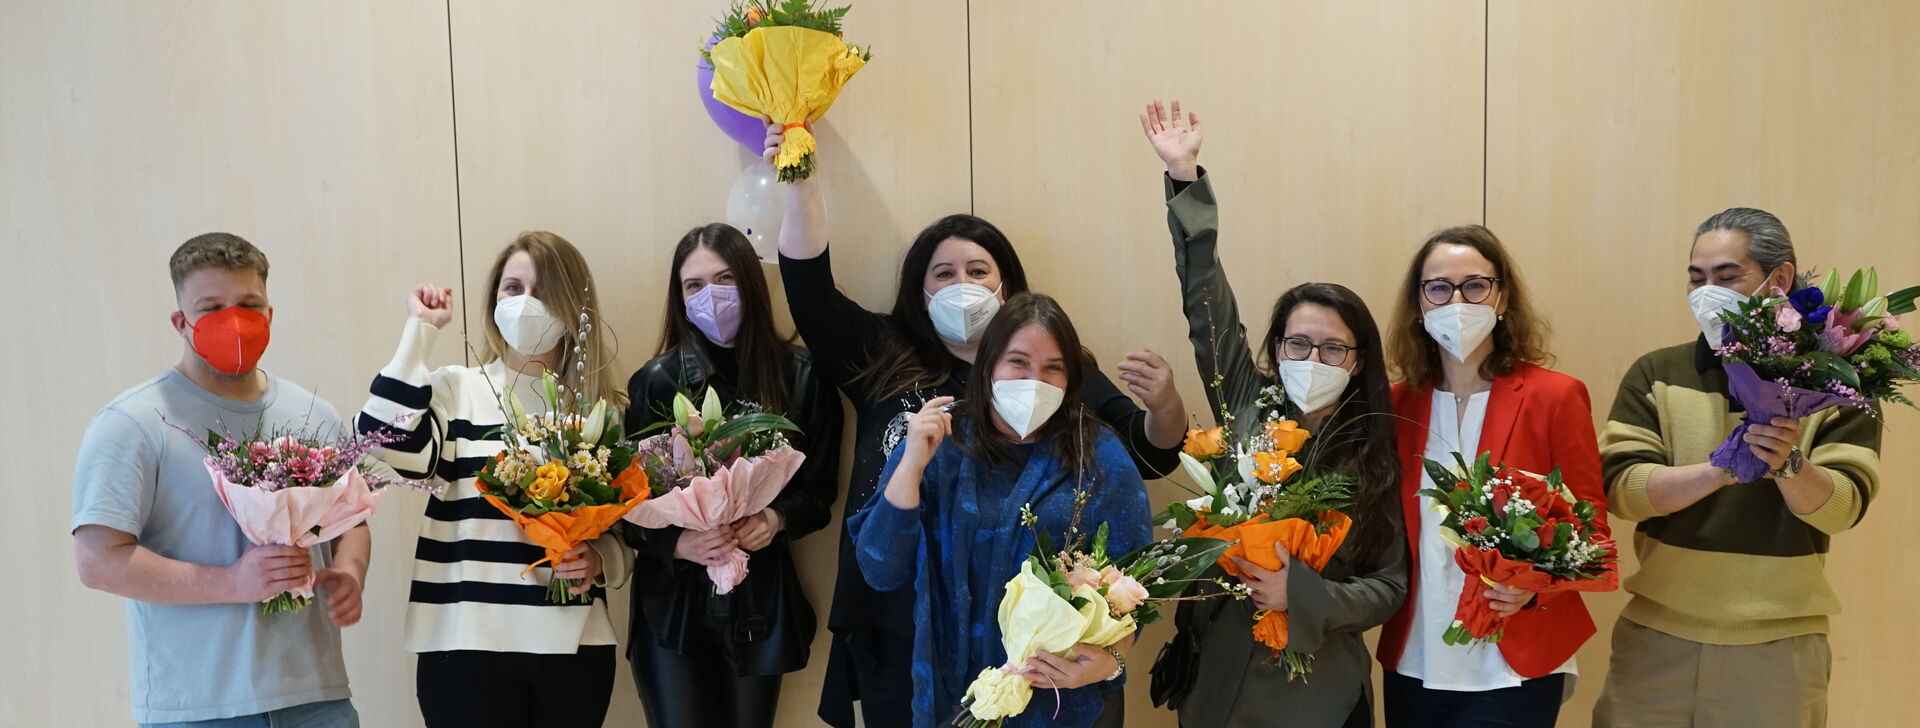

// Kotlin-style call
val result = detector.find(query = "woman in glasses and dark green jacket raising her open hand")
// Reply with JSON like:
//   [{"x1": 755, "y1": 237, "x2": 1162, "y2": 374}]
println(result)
[{"x1": 1140, "y1": 102, "x2": 1407, "y2": 728}]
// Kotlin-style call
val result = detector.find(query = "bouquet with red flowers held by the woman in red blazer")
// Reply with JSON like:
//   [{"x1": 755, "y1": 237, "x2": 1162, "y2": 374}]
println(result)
[{"x1": 1419, "y1": 453, "x2": 1620, "y2": 645}]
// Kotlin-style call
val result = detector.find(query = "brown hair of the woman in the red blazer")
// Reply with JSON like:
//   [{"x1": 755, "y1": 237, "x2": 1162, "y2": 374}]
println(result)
[{"x1": 1388, "y1": 225, "x2": 1553, "y2": 388}]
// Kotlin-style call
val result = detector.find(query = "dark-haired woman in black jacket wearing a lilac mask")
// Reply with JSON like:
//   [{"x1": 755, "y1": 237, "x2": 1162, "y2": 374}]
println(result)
[{"x1": 622, "y1": 223, "x2": 841, "y2": 728}]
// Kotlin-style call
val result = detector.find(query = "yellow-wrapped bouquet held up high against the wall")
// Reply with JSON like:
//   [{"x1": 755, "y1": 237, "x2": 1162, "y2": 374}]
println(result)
[{"x1": 701, "y1": 0, "x2": 872, "y2": 182}]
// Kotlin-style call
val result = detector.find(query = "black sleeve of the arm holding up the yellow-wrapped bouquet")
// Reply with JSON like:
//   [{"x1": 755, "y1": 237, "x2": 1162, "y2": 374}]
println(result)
[{"x1": 780, "y1": 250, "x2": 887, "y2": 388}]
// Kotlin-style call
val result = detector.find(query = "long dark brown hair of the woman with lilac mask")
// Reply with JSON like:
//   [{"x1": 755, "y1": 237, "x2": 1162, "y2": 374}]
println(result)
[{"x1": 655, "y1": 223, "x2": 791, "y2": 413}]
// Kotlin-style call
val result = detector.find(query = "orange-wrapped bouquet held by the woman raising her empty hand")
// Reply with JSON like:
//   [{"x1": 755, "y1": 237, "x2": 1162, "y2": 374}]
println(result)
[{"x1": 1154, "y1": 386, "x2": 1354, "y2": 680}]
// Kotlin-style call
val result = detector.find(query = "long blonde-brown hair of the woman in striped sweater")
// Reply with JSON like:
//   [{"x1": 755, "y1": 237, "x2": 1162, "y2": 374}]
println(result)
[{"x1": 478, "y1": 231, "x2": 626, "y2": 409}]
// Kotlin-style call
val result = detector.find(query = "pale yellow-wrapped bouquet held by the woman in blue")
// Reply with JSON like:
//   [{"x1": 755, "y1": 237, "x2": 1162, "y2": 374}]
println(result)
[{"x1": 950, "y1": 507, "x2": 1231, "y2": 728}]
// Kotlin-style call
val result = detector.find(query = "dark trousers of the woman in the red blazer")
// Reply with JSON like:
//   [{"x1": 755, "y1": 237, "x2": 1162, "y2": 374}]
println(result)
[{"x1": 1384, "y1": 670, "x2": 1567, "y2": 728}]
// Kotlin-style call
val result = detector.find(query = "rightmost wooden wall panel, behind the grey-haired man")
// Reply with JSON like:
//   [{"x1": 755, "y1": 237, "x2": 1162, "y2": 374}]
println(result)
[{"x1": 1488, "y1": 0, "x2": 1920, "y2": 726}]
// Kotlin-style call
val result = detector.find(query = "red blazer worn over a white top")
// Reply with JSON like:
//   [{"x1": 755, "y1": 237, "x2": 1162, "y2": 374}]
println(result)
[{"x1": 1377, "y1": 363, "x2": 1607, "y2": 678}]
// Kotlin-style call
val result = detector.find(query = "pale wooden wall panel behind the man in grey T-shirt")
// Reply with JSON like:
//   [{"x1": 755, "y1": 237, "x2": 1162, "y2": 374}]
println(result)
[{"x1": 0, "y1": 0, "x2": 459, "y2": 726}]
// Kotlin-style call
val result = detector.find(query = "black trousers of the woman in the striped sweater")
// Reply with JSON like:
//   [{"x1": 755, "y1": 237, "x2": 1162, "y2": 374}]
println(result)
[{"x1": 415, "y1": 645, "x2": 614, "y2": 728}]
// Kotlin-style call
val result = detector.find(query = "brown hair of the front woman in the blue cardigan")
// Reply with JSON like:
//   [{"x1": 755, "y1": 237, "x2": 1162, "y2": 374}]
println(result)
[{"x1": 954, "y1": 294, "x2": 1106, "y2": 482}]
